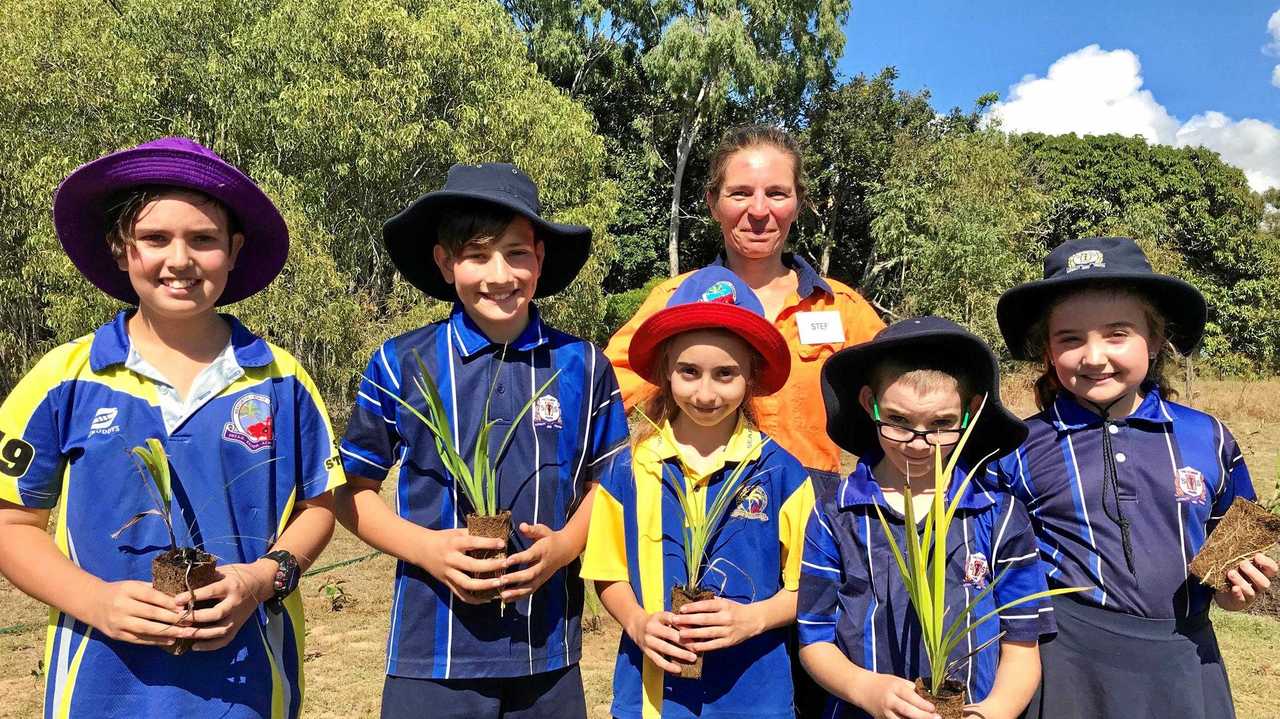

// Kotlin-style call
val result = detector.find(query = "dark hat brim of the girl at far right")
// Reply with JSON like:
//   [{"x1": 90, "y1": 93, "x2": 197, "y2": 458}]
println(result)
[{"x1": 996, "y1": 273, "x2": 1208, "y2": 361}]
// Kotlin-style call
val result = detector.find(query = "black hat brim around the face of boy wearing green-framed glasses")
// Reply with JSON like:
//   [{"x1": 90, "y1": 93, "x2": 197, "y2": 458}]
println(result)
[{"x1": 822, "y1": 331, "x2": 1027, "y2": 462}]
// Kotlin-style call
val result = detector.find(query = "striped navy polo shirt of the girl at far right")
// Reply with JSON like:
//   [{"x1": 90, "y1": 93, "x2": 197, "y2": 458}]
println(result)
[{"x1": 989, "y1": 386, "x2": 1254, "y2": 619}]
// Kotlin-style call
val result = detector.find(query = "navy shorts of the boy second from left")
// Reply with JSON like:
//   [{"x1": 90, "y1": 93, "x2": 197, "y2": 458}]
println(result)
[{"x1": 383, "y1": 664, "x2": 586, "y2": 719}]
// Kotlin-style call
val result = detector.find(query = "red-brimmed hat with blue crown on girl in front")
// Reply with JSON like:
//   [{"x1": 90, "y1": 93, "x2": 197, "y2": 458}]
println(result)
[{"x1": 627, "y1": 265, "x2": 791, "y2": 394}]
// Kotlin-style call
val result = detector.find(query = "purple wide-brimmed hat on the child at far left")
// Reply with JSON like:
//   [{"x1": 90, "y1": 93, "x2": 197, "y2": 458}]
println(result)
[{"x1": 54, "y1": 137, "x2": 289, "y2": 304}]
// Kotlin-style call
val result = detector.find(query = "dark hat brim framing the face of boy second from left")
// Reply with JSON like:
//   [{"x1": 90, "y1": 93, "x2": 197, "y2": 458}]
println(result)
[{"x1": 383, "y1": 189, "x2": 591, "y2": 302}]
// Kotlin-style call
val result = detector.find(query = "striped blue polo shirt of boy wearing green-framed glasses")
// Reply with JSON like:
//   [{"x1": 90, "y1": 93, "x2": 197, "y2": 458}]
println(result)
[{"x1": 796, "y1": 454, "x2": 1056, "y2": 718}]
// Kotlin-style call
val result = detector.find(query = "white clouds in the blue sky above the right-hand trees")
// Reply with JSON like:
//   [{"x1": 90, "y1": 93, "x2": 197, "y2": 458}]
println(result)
[{"x1": 988, "y1": 43, "x2": 1280, "y2": 192}]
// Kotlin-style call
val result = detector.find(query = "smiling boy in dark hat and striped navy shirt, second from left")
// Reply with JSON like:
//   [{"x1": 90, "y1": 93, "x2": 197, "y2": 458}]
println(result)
[{"x1": 339, "y1": 164, "x2": 627, "y2": 719}]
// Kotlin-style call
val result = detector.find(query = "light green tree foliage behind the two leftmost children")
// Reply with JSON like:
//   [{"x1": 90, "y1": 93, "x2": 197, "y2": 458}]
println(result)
[{"x1": 0, "y1": 0, "x2": 617, "y2": 397}]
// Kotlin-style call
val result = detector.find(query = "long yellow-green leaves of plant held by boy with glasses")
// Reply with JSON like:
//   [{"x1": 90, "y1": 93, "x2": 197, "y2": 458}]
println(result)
[{"x1": 874, "y1": 398, "x2": 1088, "y2": 696}]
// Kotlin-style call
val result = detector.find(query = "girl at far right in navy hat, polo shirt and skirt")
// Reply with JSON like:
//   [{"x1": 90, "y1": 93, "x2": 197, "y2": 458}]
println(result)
[{"x1": 996, "y1": 237, "x2": 1276, "y2": 719}]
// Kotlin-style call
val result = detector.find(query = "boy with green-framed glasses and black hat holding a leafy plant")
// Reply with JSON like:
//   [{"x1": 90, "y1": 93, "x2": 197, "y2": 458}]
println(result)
[{"x1": 797, "y1": 317, "x2": 1055, "y2": 719}]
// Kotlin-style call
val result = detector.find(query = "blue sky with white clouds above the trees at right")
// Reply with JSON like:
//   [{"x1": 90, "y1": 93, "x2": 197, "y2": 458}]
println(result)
[{"x1": 840, "y1": 0, "x2": 1280, "y2": 189}]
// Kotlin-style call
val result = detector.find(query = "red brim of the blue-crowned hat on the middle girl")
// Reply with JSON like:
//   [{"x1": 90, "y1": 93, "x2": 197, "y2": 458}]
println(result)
[{"x1": 627, "y1": 302, "x2": 791, "y2": 395}]
